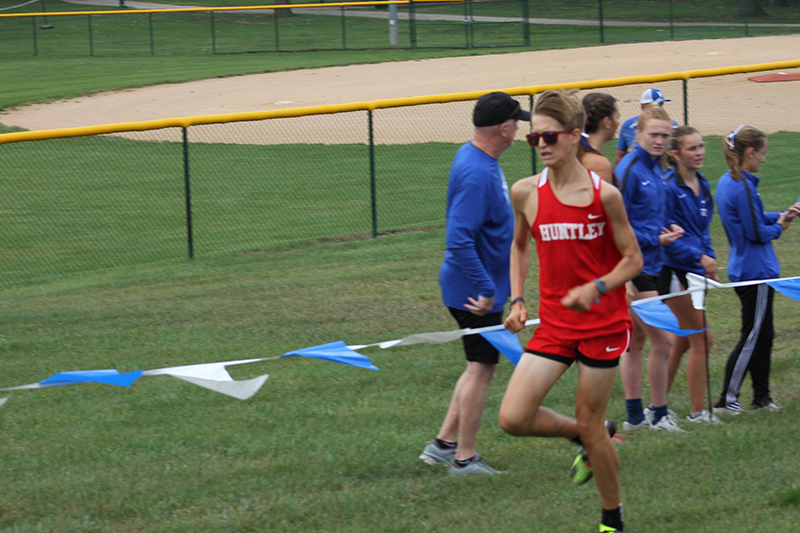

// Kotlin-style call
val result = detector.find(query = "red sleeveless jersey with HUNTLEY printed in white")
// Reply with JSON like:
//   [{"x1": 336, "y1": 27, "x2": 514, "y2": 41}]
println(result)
[{"x1": 531, "y1": 169, "x2": 633, "y2": 339}]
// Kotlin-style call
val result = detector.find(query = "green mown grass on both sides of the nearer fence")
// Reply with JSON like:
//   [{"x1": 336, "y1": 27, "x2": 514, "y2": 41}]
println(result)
[{"x1": 0, "y1": 2, "x2": 800, "y2": 533}]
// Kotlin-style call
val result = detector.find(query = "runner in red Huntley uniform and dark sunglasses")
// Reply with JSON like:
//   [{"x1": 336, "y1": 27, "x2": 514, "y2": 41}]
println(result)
[{"x1": 500, "y1": 90, "x2": 642, "y2": 532}]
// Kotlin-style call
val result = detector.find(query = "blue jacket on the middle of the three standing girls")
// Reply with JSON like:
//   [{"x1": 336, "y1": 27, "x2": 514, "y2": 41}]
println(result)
[{"x1": 664, "y1": 168, "x2": 717, "y2": 276}]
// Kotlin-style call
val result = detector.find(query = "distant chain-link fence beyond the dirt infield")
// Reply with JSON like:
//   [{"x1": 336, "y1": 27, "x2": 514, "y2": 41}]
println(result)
[{"x1": 0, "y1": 0, "x2": 800, "y2": 57}]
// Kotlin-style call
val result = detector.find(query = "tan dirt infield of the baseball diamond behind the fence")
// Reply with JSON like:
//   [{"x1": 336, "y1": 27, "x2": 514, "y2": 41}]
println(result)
[{"x1": 0, "y1": 35, "x2": 800, "y2": 144}]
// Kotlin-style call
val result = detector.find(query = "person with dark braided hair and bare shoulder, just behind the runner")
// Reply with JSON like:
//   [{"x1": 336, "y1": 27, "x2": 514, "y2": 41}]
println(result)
[{"x1": 578, "y1": 93, "x2": 620, "y2": 183}]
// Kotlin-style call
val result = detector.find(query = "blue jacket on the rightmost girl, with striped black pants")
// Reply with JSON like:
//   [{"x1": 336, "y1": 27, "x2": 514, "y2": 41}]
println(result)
[{"x1": 715, "y1": 170, "x2": 783, "y2": 282}]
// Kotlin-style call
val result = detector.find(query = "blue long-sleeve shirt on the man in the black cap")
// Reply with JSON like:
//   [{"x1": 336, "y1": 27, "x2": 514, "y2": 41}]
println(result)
[{"x1": 439, "y1": 142, "x2": 514, "y2": 312}]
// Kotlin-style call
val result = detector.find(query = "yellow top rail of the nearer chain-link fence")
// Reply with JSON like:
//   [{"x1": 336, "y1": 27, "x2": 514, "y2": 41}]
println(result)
[{"x1": 0, "y1": 60, "x2": 800, "y2": 144}]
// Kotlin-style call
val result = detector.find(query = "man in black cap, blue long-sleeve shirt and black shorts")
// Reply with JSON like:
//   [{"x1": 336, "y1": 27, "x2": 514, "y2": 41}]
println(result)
[{"x1": 419, "y1": 92, "x2": 531, "y2": 475}]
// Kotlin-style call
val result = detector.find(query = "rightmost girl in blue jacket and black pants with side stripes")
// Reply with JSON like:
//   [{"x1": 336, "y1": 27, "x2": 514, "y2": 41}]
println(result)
[{"x1": 714, "y1": 125, "x2": 800, "y2": 415}]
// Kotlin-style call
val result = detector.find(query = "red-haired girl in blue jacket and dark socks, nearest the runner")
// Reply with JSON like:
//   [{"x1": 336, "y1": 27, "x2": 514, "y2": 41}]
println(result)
[{"x1": 614, "y1": 107, "x2": 683, "y2": 431}]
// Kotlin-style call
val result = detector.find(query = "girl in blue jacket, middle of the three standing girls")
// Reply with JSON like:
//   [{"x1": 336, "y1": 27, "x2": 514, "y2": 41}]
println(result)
[{"x1": 658, "y1": 126, "x2": 719, "y2": 424}]
